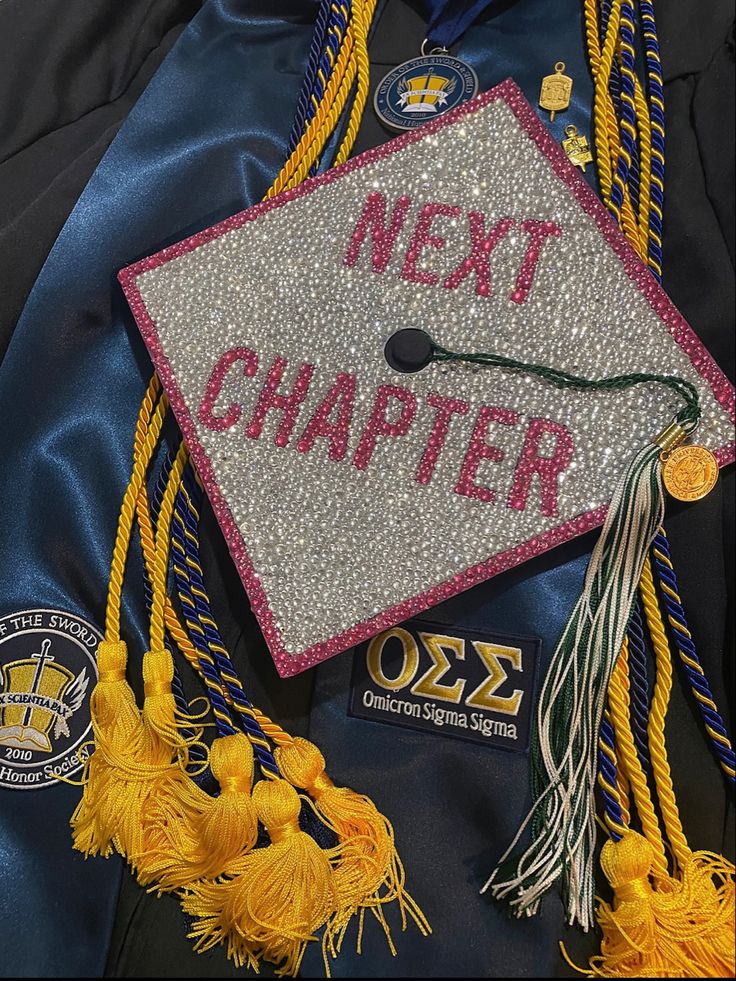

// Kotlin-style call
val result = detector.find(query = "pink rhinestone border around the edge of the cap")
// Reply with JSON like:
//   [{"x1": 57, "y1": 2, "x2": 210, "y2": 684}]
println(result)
[{"x1": 118, "y1": 79, "x2": 736, "y2": 678}]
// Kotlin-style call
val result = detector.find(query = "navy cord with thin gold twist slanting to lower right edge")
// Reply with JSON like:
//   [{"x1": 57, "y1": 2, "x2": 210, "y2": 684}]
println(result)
[{"x1": 652, "y1": 528, "x2": 736, "y2": 784}]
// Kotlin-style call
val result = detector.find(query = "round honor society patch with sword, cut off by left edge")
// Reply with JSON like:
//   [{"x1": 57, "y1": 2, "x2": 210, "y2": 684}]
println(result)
[{"x1": 0, "y1": 610, "x2": 102, "y2": 790}]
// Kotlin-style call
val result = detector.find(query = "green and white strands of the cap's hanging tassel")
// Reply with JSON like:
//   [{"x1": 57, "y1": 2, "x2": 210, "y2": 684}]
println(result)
[{"x1": 482, "y1": 443, "x2": 664, "y2": 930}]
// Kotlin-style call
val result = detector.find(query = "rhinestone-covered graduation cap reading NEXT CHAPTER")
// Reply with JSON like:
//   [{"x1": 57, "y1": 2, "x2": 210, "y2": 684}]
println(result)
[{"x1": 120, "y1": 81, "x2": 733, "y2": 677}]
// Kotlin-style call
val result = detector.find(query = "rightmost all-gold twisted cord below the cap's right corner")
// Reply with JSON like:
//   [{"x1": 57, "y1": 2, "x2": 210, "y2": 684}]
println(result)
[{"x1": 639, "y1": 557, "x2": 692, "y2": 866}]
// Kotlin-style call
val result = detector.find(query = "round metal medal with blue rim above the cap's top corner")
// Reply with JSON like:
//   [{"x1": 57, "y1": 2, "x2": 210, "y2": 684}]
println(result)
[{"x1": 373, "y1": 54, "x2": 478, "y2": 130}]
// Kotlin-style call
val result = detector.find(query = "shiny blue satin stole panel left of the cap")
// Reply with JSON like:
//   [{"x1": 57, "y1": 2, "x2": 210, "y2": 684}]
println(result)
[{"x1": 0, "y1": 0, "x2": 316, "y2": 976}]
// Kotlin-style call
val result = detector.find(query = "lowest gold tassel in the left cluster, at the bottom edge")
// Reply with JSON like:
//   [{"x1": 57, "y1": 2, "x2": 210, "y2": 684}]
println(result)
[{"x1": 182, "y1": 780, "x2": 337, "y2": 976}]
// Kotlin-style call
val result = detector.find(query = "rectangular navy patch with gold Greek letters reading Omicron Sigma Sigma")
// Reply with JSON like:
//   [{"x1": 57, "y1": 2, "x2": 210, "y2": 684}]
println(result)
[{"x1": 349, "y1": 620, "x2": 542, "y2": 752}]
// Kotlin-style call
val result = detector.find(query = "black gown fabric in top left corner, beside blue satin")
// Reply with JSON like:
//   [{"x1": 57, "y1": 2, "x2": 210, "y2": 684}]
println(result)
[{"x1": 0, "y1": 0, "x2": 201, "y2": 359}]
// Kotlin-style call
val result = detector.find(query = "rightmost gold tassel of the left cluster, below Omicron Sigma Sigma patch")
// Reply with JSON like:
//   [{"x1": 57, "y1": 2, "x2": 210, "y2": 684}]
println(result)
[{"x1": 275, "y1": 737, "x2": 431, "y2": 953}]
